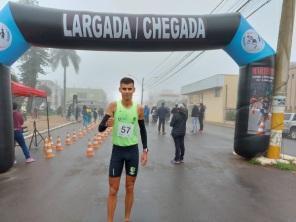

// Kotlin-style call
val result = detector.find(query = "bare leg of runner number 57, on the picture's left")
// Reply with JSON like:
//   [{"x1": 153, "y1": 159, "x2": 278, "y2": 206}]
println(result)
[{"x1": 108, "y1": 177, "x2": 120, "y2": 222}]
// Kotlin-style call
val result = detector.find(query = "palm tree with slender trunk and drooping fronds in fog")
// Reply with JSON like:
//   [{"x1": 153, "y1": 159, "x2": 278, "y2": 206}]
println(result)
[{"x1": 51, "y1": 49, "x2": 81, "y2": 114}]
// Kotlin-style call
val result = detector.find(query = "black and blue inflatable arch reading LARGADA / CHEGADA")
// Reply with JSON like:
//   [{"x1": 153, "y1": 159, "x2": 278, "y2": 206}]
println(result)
[{"x1": 0, "y1": 3, "x2": 275, "y2": 172}]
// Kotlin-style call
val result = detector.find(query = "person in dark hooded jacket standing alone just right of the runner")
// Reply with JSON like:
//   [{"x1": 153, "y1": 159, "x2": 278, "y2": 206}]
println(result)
[{"x1": 170, "y1": 104, "x2": 188, "y2": 164}]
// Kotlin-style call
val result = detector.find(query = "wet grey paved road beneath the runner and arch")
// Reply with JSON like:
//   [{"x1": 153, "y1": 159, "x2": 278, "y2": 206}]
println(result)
[{"x1": 0, "y1": 122, "x2": 296, "y2": 222}]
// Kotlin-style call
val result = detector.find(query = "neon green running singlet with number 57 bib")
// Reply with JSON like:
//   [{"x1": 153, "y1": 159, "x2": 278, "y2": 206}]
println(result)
[{"x1": 112, "y1": 101, "x2": 138, "y2": 146}]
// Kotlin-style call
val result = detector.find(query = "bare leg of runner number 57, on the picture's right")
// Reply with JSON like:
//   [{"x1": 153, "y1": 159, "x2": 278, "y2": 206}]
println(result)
[{"x1": 125, "y1": 175, "x2": 136, "y2": 222}]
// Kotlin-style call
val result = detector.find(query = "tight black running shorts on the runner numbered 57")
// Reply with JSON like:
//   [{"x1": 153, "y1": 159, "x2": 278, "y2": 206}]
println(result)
[{"x1": 109, "y1": 144, "x2": 139, "y2": 177}]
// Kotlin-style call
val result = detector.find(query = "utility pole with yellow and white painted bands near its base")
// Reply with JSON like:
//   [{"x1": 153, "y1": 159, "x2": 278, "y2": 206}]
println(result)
[{"x1": 267, "y1": 0, "x2": 295, "y2": 159}]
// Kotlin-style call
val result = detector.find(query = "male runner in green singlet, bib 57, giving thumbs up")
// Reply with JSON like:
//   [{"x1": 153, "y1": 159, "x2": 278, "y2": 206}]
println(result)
[{"x1": 99, "y1": 77, "x2": 148, "y2": 222}]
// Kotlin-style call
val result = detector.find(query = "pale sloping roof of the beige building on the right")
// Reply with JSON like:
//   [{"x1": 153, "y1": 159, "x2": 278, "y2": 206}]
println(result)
[{"x1": 181, "y1": 74, "x2": 234, "y2": 95}]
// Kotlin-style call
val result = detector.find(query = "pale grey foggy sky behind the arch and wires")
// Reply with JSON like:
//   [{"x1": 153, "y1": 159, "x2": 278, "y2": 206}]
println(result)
[{"x1": 0, "y1": 0, "x2": 296, "y2": 100}]
